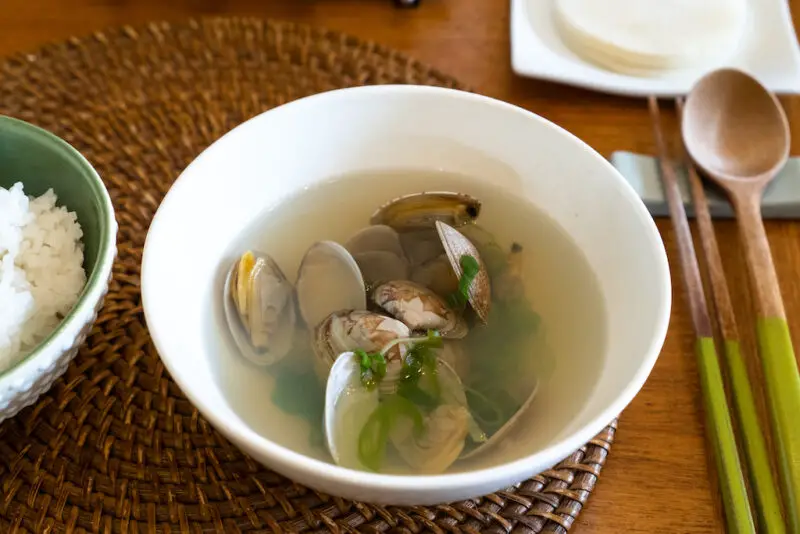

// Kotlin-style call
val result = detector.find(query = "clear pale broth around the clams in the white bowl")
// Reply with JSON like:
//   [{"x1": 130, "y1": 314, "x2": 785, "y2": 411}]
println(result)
[{"x1": 211, "y1": 170, "x2": 606, "y2": 471}]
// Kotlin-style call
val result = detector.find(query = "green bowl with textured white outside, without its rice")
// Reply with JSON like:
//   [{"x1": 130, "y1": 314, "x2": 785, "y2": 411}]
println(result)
[{"x1": 0, "y1": 115, "x2": 117, "y2": 421}]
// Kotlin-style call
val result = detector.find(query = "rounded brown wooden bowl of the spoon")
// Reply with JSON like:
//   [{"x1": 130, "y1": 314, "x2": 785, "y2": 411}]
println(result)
[{"x1": 682, "y1": 69, "x2": 790, "y2": 187}]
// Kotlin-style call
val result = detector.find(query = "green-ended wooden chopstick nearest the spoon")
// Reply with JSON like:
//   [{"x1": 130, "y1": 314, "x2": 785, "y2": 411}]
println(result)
[{"x1": 675, "y1": 98, "x2": 786, "y2": 533}]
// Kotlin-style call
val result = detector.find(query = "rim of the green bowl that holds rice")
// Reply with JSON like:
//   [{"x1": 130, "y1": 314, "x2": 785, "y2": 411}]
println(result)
[{"x1": 0, "y1": 115, "x2": 117, "y2": 382}]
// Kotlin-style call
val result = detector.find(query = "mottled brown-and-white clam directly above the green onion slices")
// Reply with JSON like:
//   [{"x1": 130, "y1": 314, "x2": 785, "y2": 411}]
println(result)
[{"x1": 313, "y1": 310, "x2": 411, "y2": 380}]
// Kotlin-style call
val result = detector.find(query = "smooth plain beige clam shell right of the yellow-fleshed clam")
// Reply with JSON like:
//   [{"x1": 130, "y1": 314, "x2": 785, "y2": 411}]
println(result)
[{"x1": 296, "y1": 241, "x2": 367, "y2": 329}]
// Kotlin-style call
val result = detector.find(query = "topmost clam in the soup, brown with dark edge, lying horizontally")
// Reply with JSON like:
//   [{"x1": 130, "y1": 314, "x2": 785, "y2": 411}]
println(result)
[{"x1": 370, "y1": 191, "x2": 481, "y2": 231}]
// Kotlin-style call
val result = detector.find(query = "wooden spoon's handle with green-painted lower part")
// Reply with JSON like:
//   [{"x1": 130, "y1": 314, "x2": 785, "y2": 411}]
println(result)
[{"x1": 734, "y1": 195, "x2": 800, "y2": 533}]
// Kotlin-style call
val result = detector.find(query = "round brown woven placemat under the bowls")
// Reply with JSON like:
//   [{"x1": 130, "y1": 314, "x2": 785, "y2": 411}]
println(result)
[{"x1": 0, "y1": 19, "x2": 616, "y2": 533}]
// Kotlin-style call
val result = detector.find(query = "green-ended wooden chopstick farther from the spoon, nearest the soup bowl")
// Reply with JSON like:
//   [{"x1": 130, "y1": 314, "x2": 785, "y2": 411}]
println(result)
[{"x1": 648, "y1": 96, "x2": 756, "y2": 533}]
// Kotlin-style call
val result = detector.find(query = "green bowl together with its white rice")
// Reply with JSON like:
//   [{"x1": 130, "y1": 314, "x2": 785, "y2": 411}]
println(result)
[{"x1": 0, "y1": 116, "x2": 117, "y2": 421}]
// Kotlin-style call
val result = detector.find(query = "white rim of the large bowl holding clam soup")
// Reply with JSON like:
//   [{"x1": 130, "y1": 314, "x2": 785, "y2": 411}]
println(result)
[{"x1": 141, "y1": 84, "x2": 672, "y2": 502}]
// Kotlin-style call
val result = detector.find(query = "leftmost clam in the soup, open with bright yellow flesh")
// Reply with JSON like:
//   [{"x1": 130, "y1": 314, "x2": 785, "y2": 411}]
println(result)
[{"x1": 223, "y1": 251, "x2": 297, "y2": 365}]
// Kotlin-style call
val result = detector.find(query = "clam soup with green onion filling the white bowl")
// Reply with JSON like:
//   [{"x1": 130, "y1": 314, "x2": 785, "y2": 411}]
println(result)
[{"x1": 212, "y1": 171, "x2": 606, "y2": 474}]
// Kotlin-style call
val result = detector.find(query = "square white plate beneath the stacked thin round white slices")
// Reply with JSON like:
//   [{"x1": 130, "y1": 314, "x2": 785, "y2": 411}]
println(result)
[{"x1": 511, "y1": 0, "x2": 800, "y2": 97}]
